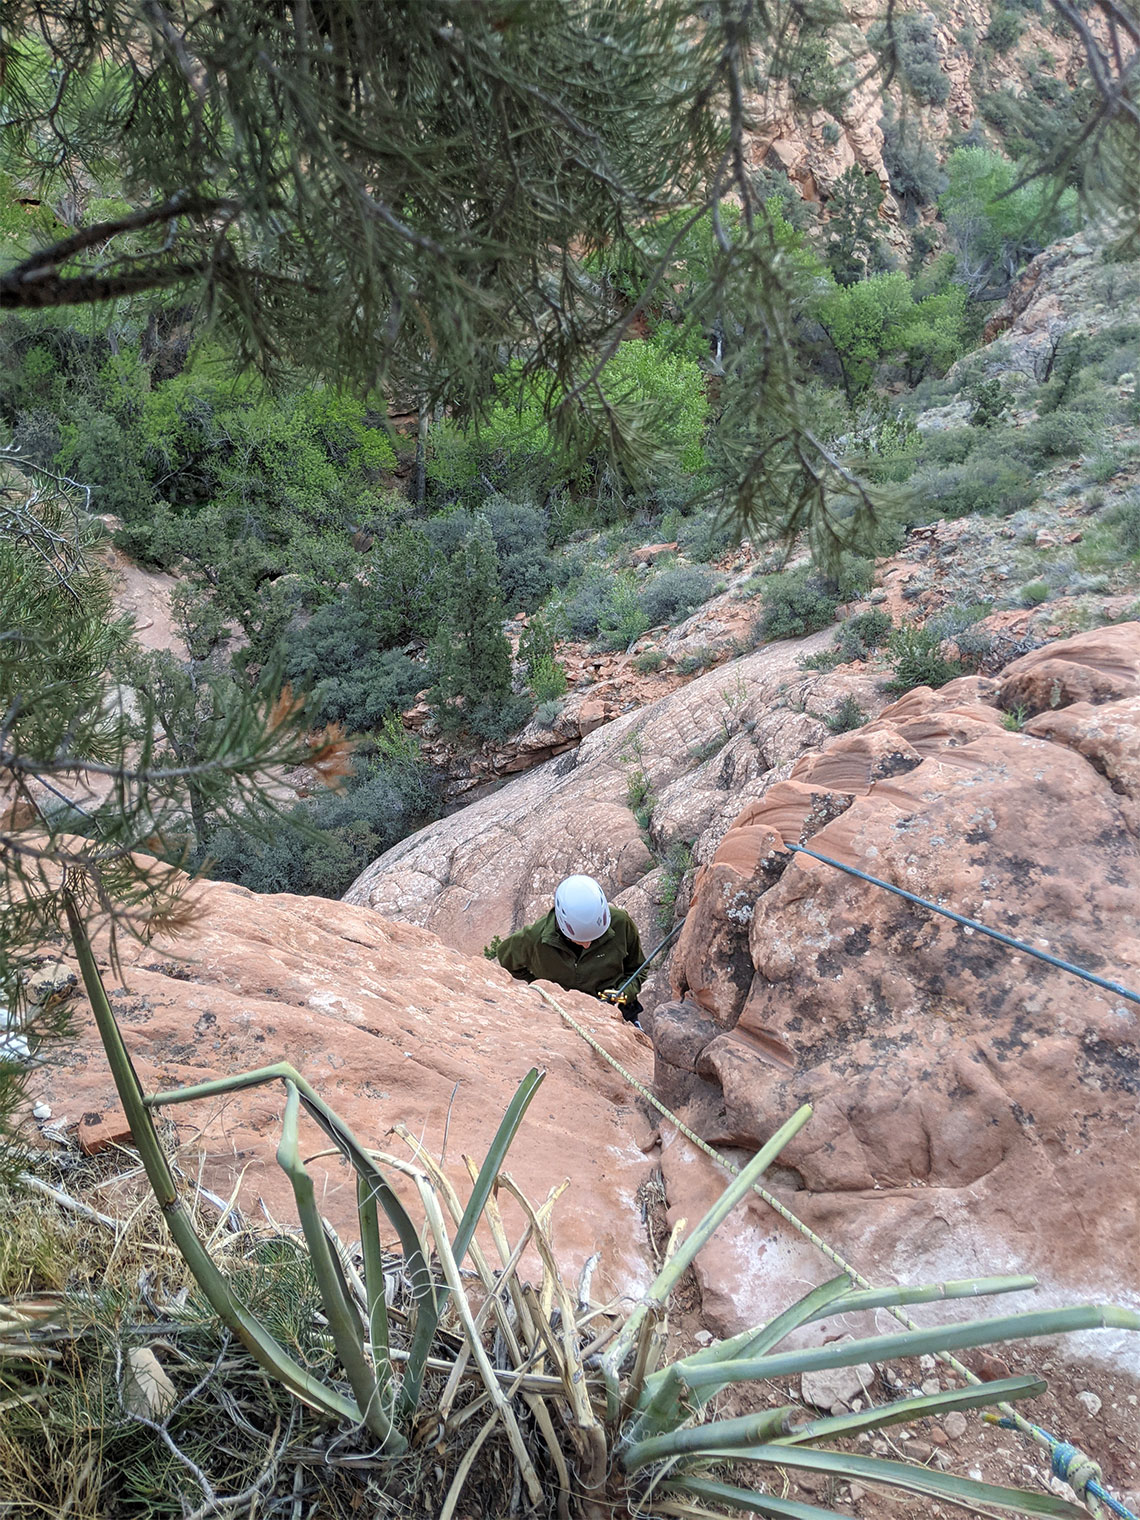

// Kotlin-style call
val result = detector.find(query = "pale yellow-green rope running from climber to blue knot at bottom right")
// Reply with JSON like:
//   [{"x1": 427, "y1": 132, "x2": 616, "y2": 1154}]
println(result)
[{"x1": 535, "y1": 984, "x2": 1138, "y2": 1520}]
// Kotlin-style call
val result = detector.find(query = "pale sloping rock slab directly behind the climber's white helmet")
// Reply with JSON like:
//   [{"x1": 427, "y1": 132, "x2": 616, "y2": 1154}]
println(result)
[{"x1": 345, "y1": 632, "x2": 883, "y2": 952}]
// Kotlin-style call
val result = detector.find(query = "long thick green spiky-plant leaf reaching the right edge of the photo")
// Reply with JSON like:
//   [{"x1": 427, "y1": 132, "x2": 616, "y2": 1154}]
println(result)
[{"x1": 674, "y1": 1304, "x2": 1140, "y2": 1406}]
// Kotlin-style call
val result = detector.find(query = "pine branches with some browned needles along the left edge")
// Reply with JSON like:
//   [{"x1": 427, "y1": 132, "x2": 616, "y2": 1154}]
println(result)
[{"x1": 0, "y1": 451, "x2": 334, "y2": 1129}]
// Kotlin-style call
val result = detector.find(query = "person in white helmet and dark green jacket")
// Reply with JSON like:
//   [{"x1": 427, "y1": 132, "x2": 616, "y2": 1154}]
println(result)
[{"x1": 497, "y1": 876, "x2": 644, "y2": 1023}]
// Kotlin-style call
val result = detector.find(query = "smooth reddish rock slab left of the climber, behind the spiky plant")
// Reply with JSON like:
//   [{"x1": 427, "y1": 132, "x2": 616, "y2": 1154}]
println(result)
[{"x1": 30, "y1": 883, "x2": 654, "y2": 1297}]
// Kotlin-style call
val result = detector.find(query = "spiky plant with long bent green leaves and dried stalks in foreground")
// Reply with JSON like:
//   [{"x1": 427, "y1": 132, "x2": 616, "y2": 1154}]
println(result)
[{"x1": 67, "y1": 900, "x2": 1140, "y2": 1520}]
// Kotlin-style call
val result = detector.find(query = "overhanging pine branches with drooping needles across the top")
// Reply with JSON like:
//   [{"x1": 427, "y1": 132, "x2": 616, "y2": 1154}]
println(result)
[{"x1": 0, "y1": 0, "x2": 1140, "y2": 541}]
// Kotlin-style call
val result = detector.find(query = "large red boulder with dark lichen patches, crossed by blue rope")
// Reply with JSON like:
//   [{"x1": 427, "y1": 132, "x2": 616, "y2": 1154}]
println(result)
[{"x1": 652, "y1": 623, "x2": 1140, "y2": 1357}]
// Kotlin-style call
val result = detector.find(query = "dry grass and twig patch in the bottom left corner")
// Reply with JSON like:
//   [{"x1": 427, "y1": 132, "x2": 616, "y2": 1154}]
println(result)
[{"x1": 0, "y1": 1151, "x2": 571, "y2": 1520}]
